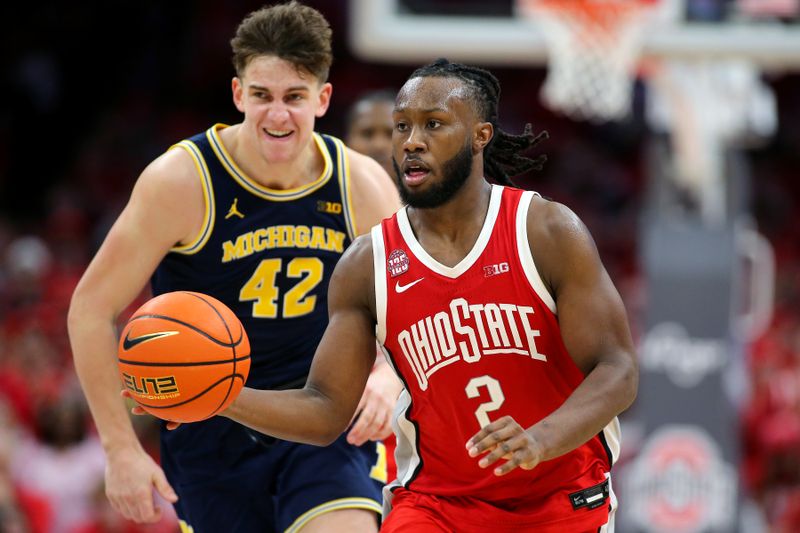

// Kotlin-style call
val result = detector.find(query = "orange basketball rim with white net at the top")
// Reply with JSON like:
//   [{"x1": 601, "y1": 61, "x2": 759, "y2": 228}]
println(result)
[{"x1": 516, "y1": 0, "x2": 655, "y2": 122}]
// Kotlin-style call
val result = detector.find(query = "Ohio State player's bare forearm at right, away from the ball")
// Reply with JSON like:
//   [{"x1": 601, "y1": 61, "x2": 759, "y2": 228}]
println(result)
[{"x1": 528, "y1": 360, "x2": 638, "y2": 461}]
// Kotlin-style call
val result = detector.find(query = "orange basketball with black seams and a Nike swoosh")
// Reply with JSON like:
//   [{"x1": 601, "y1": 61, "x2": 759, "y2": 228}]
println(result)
[{"x1": 117, "y1": 291, "x2": 250, "y2": 422}]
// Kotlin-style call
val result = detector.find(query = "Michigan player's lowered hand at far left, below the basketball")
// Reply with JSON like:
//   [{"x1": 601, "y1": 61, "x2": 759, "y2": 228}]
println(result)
[{"x1": 106, "y1": 446, "x2": 178, "y2": 523}]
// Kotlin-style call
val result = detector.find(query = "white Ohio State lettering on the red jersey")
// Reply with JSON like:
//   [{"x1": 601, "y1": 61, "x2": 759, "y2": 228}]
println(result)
[{"x1": 397, "y1": 298, "x2": 547, "y2": 390}]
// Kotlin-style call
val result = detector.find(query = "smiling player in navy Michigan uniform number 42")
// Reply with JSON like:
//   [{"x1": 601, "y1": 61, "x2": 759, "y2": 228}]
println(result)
[{"x1": 69, "y1": 2, "x2": 401, "y2": 533}]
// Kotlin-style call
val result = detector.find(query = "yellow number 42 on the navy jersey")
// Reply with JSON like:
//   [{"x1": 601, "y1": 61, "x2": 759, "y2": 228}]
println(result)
[{"x1": 239, "y1": 257, "x2": 325, "y2": 318}]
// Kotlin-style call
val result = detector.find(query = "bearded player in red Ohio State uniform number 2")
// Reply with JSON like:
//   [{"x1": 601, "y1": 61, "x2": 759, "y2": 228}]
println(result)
[{"x1": 195, "y1": 56, "x2": 638, "y2": 533}]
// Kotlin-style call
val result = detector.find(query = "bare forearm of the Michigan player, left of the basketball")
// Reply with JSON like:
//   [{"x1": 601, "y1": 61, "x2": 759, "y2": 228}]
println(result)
[{"x1": 68, "y1": 305, "x2": 139, "y2": 454}]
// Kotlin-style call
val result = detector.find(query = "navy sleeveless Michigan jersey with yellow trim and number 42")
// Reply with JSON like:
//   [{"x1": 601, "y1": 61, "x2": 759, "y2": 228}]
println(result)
[{"x1": 152, "y1": 124, "x2": 354, "y2": 389}]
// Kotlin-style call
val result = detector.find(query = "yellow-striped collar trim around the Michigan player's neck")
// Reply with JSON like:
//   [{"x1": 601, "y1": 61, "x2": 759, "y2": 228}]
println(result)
[{"x1": 206, "y1": 124, "x2": 333, "y2": 202}]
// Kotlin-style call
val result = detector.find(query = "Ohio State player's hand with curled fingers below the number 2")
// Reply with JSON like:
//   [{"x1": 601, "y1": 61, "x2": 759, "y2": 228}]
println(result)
[{"x1": 467, "y1": 416, "x2": 542, "y2": 476}]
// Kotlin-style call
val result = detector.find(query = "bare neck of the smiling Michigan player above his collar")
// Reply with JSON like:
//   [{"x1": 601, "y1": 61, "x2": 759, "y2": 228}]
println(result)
[{"x1": 223, "y1": 126, "x2": 325, "y2": 190}]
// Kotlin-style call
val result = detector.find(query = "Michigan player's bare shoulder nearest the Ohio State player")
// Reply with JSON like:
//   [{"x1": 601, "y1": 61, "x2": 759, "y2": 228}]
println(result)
[{"x1": 347, "y1": 148, "x2": 401, "y2": 234}]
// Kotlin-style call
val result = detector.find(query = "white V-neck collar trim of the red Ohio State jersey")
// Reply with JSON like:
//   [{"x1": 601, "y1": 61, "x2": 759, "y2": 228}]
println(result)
[{"x1": 397, "y1": 185, "x2": 503, "y2": 279}]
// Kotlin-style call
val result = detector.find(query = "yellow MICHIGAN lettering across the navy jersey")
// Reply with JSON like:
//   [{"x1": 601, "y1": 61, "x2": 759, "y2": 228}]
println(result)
[{"x1": 222, "y1": 225, "x2": 347, "y2": 263}]
